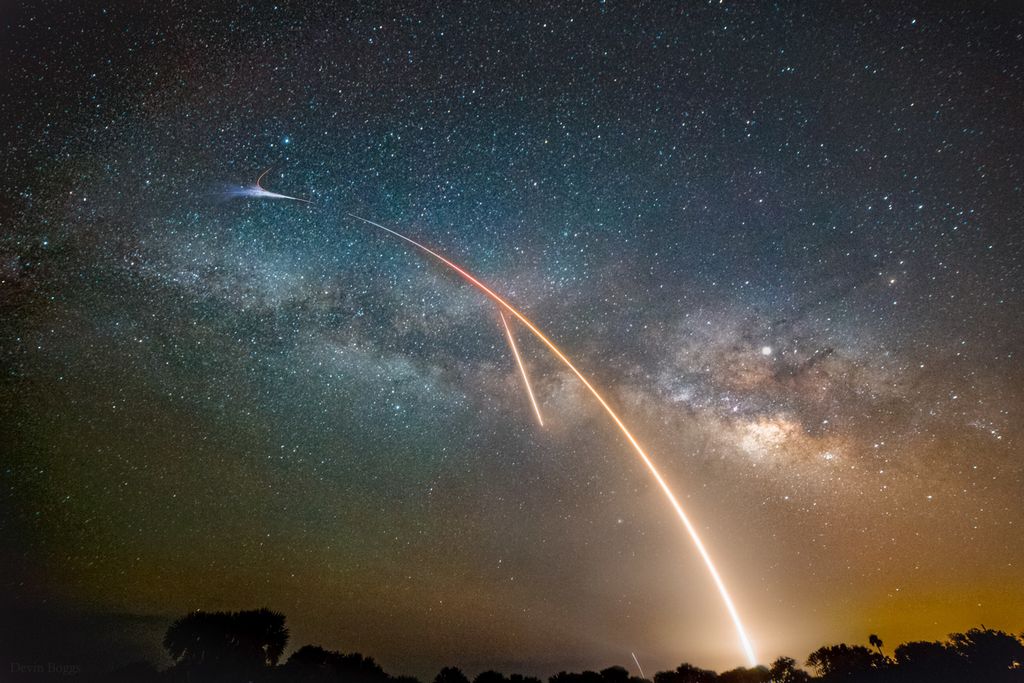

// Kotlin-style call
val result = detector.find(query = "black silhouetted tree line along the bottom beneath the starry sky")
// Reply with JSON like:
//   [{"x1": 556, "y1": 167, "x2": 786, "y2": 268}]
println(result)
[{"x1": 103, "y1": 608, "x2": 1024, "y2": 683}]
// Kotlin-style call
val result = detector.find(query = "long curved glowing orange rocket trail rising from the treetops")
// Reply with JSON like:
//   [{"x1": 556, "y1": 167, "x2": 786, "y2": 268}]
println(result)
[{"x1": 347, "y1": 213, "x2": 758, "y2": 667}]
